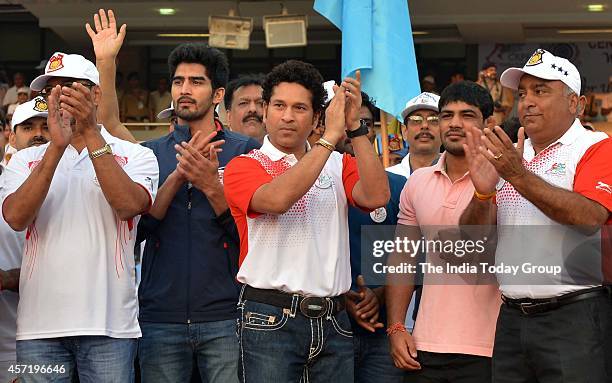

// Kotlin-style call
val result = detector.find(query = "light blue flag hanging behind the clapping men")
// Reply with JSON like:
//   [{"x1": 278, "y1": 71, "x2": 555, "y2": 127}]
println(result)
[{"x1": 314, "y1": 0, "x2": 421, "y2": 121}]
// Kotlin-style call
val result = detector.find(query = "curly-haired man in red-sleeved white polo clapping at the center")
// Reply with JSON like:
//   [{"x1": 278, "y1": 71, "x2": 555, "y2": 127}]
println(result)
[{"x1": 224, "y1": 60, "x2": 389, "y2": 382}]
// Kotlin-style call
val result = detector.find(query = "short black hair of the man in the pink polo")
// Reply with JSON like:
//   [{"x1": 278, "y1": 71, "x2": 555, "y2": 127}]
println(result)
[{"x1": 438, "y1": 81, "x2": 493, "y2": 120}]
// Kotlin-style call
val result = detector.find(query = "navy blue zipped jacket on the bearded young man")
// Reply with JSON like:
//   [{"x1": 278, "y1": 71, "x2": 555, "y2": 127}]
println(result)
[{"x1": 138, "y1": 126, "x2": 260, "y2": 323}]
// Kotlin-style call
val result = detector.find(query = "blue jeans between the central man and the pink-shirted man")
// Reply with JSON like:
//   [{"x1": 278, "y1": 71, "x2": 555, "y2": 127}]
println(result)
[{"x1": 353, "y1": 331, "x2": 406, "y2": 383}]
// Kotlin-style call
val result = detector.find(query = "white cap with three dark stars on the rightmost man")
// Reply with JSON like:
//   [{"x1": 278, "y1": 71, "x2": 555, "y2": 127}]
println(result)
[{"x1": 499, "y1": 49, "x2": 581, "y2": 95}]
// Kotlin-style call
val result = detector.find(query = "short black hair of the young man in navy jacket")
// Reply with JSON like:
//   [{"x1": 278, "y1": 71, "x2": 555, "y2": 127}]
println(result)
[{"x1": 168, "y1": 43, "x2": 229, "y2": 89}]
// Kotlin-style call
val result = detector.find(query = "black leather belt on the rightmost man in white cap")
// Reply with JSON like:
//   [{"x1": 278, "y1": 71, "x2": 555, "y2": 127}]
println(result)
[{"x1": 502, "y1": 286, "x2": 610, "y2": 315}]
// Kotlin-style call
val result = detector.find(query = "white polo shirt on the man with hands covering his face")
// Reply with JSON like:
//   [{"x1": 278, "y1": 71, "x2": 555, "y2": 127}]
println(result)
[{"x1": 1, "y1": 128, "x2": 159, "y2": 340}]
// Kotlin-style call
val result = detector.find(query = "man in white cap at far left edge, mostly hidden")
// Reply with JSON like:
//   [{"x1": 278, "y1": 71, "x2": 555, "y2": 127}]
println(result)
[{"x1": 0, "y1": 97, "x2": 50, "y2": 382}]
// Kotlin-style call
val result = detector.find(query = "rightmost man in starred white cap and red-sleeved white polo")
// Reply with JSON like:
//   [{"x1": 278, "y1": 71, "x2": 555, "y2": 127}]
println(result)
[{"x1": 461, "y1": 49, "x2": 612, "y2": 383}]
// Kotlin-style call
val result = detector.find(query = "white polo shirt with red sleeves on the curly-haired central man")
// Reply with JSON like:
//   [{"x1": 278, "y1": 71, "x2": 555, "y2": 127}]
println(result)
[{"x1": 224, "y1": 136, "x2": 359, "y2": 297}]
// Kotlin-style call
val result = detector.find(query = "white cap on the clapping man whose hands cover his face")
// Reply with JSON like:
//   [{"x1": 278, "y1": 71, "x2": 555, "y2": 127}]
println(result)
[{"x1": 30, "y1": 52, "x2": 100, "y2": 91}]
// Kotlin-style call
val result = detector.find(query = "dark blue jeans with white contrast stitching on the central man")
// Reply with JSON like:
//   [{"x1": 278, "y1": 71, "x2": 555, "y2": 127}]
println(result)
[{"x1": 238, "y1": 296, "x2": 353, "y2": 383}]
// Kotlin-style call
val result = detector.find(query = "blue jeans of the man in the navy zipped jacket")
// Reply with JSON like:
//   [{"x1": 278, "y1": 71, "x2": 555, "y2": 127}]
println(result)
[{"x1": 138, "y1": 319, "x2": 238, "y2": 383}]
